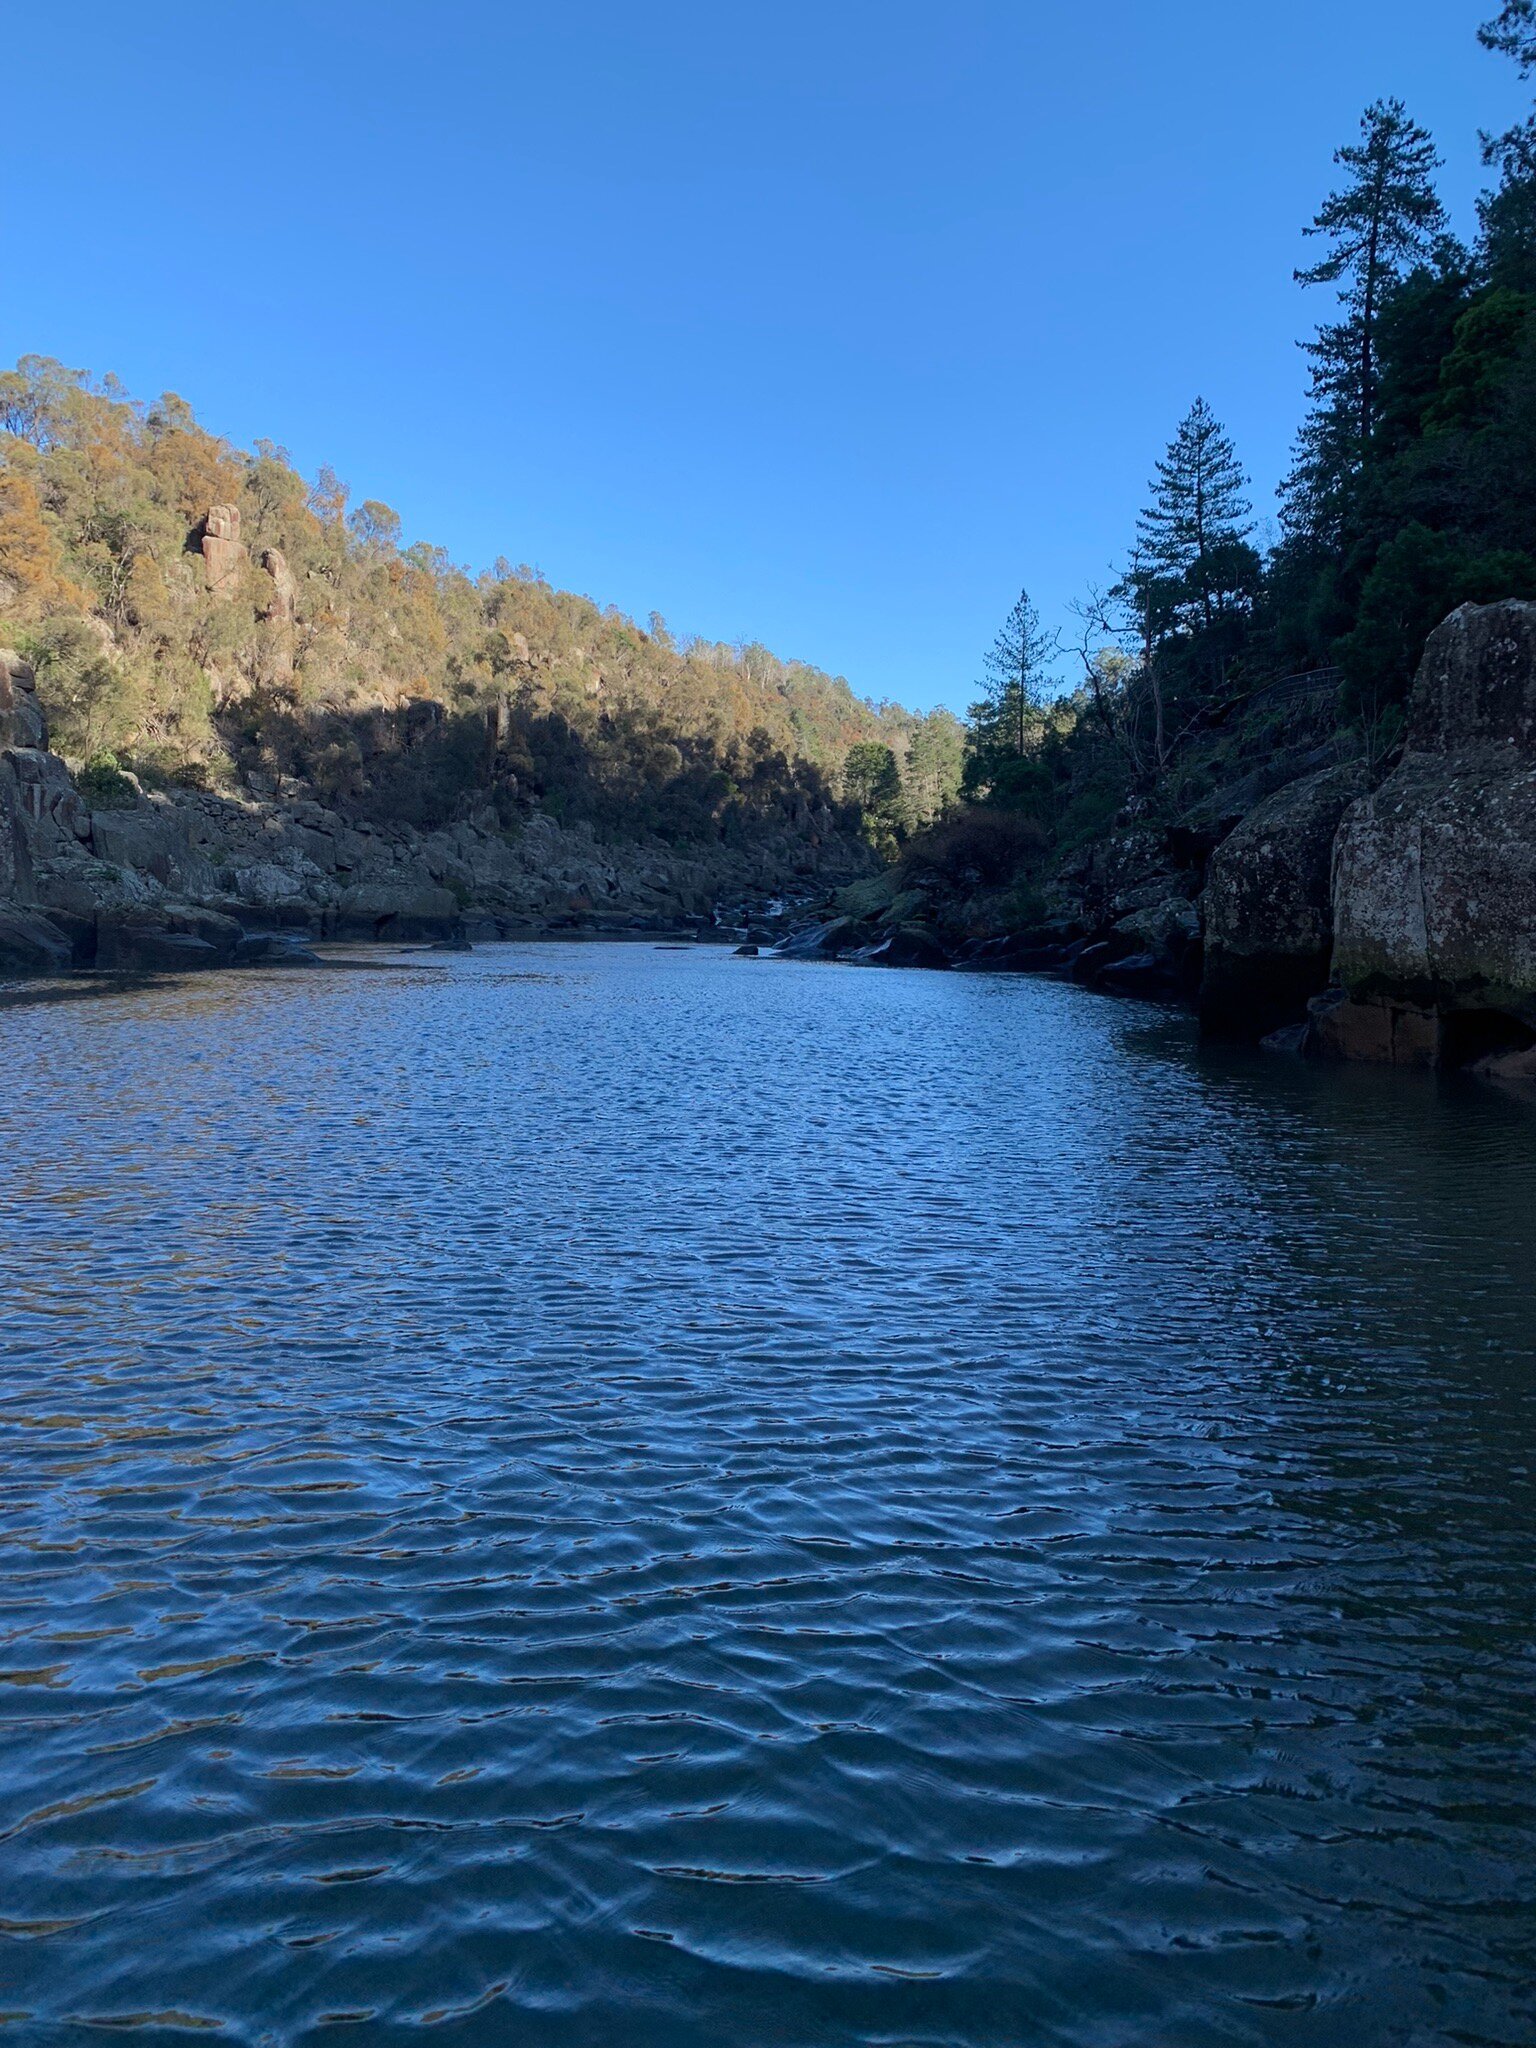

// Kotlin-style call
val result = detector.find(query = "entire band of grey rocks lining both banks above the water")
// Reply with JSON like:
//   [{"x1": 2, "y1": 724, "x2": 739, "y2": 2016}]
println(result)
[{"x1": 0, "y1": 602, "x2": 1536, "y2": 1077}]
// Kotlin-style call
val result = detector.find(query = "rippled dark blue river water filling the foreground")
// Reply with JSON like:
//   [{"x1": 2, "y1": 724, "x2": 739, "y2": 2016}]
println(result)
[{"x1": 0, "y1": 944, "x2": 1536, "y2": 2048}]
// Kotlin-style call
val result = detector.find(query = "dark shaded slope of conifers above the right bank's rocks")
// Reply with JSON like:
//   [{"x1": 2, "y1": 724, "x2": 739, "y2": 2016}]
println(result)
[{"x1": 958, "y1": 0, "x2": 1536, "y2": 895}]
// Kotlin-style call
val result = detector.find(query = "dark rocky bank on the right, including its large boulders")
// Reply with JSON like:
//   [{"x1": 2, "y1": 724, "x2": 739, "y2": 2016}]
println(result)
[{"x1": 774, "y1": 602, "x2": 1536, "y2": 1075}]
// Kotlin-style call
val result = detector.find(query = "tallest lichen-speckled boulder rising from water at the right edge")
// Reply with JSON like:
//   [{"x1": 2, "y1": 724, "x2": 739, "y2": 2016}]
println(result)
[{"x1": 1315, "y1": 602, "x2": 1536, "y2": 1067}]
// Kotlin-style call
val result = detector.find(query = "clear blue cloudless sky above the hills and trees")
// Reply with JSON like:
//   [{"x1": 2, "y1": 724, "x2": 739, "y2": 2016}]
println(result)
[{"x1": 0, "y1": 0, "x2": 1526, "y2": 707}]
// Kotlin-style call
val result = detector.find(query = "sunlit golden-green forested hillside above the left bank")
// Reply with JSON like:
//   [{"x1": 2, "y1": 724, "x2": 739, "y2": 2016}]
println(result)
[{"x1": 0, "y1": 356, "x2": 961, "y2": 840}]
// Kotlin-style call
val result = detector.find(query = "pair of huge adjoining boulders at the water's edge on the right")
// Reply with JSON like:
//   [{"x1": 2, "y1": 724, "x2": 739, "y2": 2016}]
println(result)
[{"x1": 1200, "y1": 600, "x2": 1536, "y2": 1067}]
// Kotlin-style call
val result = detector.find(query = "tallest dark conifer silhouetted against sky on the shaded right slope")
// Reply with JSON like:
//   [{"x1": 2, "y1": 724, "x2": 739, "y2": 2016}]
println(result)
[{"x1": 1288, "y1": 100, "x2": 1446, "y2": 524}]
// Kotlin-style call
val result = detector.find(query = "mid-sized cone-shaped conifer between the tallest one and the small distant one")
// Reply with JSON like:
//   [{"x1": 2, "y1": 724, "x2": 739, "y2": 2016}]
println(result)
[{"x1": 1137, "y1": 397, "x2": 1253, "y2": 627}]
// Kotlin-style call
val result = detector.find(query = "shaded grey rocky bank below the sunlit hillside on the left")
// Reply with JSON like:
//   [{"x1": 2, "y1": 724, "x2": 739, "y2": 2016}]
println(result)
[{"x1": 0, "y1": 651, "x2": 872, "y2": 975}]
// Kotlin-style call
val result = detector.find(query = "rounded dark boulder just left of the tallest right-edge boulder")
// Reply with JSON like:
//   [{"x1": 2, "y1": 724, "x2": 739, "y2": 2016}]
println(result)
[{"x1": 1200, "y1": 766, "x2": 1364, "y2": 1038}]
